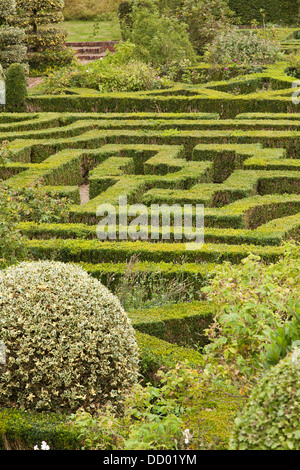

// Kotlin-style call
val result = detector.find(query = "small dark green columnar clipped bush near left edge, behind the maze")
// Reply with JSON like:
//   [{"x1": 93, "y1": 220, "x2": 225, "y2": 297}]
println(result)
[{"x1": 6, "y1": 63, "x2": 27, "y2": 112}]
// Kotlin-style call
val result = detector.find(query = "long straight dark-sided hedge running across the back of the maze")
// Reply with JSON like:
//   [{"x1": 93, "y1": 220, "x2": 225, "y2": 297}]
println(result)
[{"x1": 27, "y1": 93, "x2": 297, "y2": 118}]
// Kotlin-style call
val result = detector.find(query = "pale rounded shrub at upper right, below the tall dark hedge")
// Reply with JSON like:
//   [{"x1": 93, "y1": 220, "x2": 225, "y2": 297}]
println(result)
[{"x1": 205, "y1": 29, "x2": 280, "y2": 65}]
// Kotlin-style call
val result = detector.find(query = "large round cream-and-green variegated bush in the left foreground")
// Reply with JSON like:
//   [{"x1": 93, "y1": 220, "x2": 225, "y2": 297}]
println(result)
[{"x1": 0, "y1": 261, "x2": 138, "y2": 412}]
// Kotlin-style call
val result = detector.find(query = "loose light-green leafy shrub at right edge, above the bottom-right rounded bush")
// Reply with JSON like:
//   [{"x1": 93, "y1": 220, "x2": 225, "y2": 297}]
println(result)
[{"x1": 203, "y1": 243, "x2": 300, "y2": 383}]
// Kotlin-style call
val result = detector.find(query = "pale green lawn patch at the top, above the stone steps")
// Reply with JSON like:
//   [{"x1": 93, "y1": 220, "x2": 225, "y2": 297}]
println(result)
[{"x1": 56, "y1": 19, "x2": 121, "y2": 42}]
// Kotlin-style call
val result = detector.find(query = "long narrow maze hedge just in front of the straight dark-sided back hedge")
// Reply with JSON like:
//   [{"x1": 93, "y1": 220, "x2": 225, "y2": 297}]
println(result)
[{"x1": 6, "y1": 115, "x2": 299, "y2": 141}]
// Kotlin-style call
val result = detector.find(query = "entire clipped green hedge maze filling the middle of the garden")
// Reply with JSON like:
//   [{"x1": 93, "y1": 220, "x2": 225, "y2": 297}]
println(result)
[{"x1": 0, "y1": 70, "x2": 300, "y2": 374}]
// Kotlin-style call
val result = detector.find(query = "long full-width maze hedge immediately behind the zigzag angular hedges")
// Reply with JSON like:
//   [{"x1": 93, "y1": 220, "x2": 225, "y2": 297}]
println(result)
[{"x1": 5, "y1": 126, "x2": 300, "y2": 163}]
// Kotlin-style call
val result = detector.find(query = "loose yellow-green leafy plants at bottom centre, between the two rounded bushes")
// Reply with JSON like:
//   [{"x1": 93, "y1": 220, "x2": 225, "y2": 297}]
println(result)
[{"x1": 72, "y1": 363, "x2": 241, "y2": 450}]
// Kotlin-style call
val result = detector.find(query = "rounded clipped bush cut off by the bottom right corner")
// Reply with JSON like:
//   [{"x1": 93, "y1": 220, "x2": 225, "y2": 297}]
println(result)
[{"x1": 230, "y1": 348, "x2": 300, "y2": 450}]
